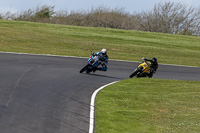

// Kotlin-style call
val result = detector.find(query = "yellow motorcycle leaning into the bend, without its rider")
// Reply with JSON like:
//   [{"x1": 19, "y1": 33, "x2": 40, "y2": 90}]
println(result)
[{"x1": 130, "y1": 61, "x2": 151, "y2": 78}]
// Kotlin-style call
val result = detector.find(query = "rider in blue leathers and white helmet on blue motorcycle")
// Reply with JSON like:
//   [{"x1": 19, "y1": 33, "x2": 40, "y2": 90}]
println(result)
[{"x1": 91, "y1": 49, "x2": 108, "y2": 72}]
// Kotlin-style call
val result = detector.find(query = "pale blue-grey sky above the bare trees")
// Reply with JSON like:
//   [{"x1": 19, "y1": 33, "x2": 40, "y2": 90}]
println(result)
[{"x1": 0, "y1": 0, "x2": 200, "y2": 13}]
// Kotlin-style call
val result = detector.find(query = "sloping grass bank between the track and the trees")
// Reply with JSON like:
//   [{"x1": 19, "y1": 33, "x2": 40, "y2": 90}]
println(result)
[{"x1": 0, "y1": 20, "x2": 200, "y2": 66}]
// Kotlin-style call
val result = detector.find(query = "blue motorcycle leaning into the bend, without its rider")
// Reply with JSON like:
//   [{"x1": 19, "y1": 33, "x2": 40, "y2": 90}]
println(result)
[{"x1": 80, "y1": 55, "x2": 102, "y2": 73}]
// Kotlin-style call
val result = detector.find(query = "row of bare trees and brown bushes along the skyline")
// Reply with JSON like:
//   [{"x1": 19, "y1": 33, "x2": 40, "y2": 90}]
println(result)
[{"x1": 0, "y1": 2, "x2": 200, "y2": 35}]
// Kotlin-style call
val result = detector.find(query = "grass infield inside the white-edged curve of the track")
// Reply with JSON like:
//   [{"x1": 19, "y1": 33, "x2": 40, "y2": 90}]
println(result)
[{"x1": 95, "y1": 78, "x2": 200, "y2": 133}]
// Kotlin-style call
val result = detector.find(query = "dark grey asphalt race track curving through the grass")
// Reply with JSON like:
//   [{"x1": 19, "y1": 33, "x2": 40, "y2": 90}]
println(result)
[{"x1": 0, "y1": 53, "x2": 200, "y2": 133}]
